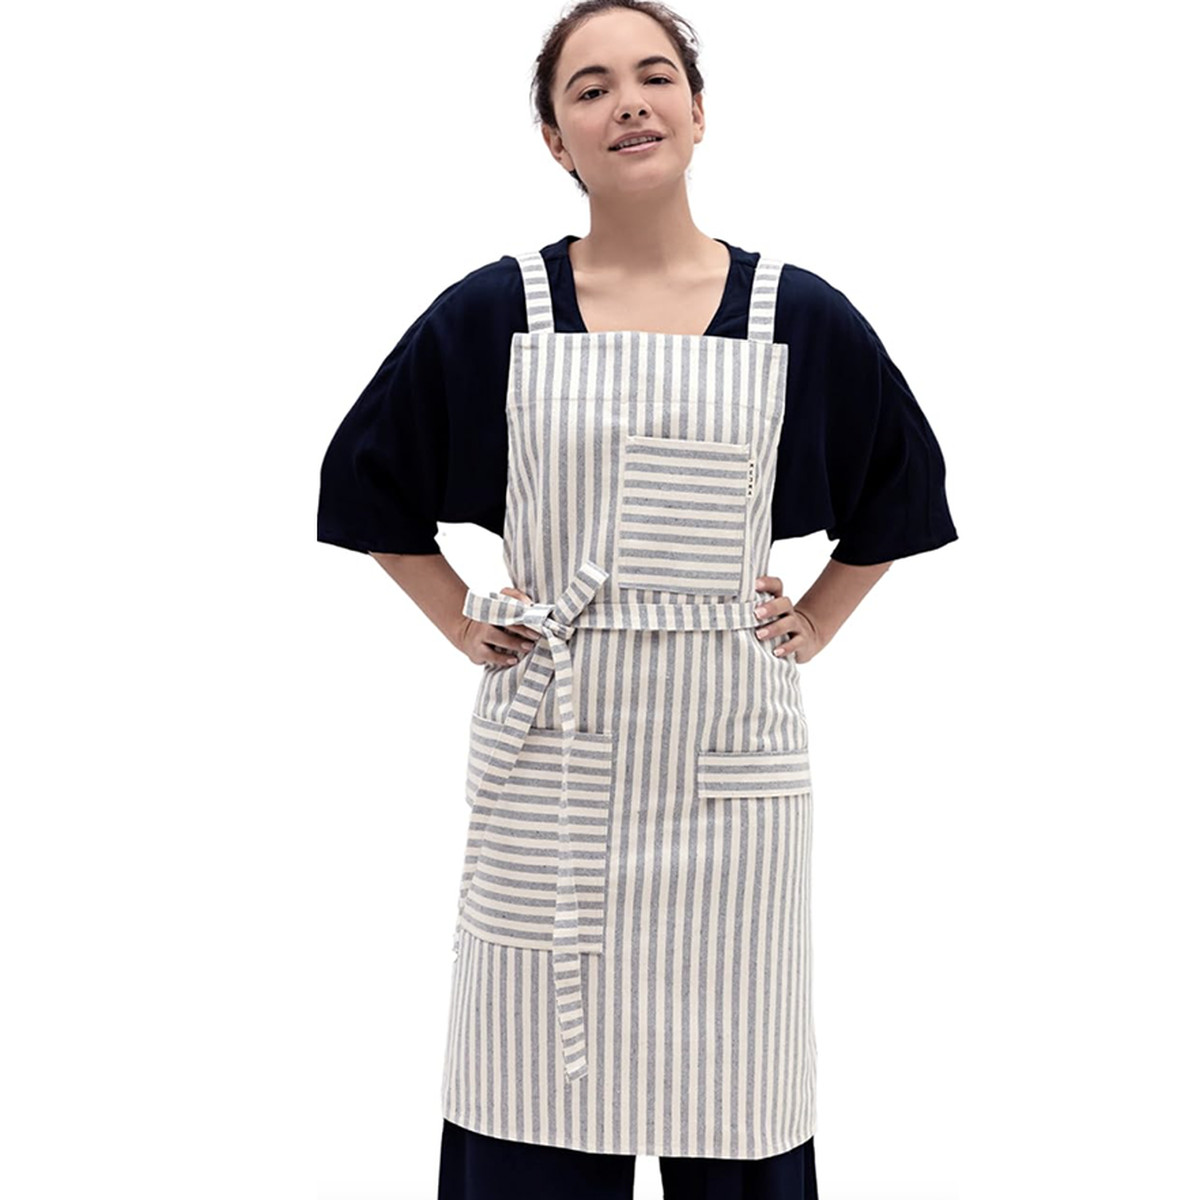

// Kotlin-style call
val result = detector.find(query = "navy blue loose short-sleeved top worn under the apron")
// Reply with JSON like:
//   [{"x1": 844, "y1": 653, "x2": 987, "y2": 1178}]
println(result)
[{"x1": 317, "y1": 234, "x2": 958, "y2": 566}]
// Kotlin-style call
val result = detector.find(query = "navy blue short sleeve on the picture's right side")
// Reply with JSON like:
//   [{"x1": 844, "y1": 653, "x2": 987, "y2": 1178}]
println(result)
[{"x1": 773, "y1": 269, "x2": 958, "y2": 566}]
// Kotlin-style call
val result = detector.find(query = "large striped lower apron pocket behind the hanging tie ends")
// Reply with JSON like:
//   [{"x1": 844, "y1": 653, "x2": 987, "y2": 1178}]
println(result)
[{"x1": 458, "y1": 715, "x2": 613, "y2": 953}]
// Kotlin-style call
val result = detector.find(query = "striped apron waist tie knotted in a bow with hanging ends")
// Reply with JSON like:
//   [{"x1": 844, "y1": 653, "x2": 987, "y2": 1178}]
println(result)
[{"x1": 462, "y1": 559, "x2": 769, "y2": 1080}]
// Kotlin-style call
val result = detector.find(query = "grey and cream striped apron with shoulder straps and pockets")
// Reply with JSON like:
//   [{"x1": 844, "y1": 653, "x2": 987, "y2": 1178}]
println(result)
[{"x1": 442, "y1": 251, "x2": 816, "y2": 1159}]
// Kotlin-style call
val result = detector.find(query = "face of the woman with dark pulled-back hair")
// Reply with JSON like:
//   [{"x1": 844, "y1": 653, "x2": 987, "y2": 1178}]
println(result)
[{"x1": 542, "y1": 8, "x2": 704, "y2": 194}]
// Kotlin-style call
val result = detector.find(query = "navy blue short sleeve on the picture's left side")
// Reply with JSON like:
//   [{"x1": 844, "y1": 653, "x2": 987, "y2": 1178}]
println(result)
[{"x1": 317, "y1": 265, "x2": 512, "y2": 554}]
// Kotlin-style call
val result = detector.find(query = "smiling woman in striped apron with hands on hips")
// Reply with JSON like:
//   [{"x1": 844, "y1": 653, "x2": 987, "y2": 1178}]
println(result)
[{"x1": 318, "y1": 0, "x2": 956, "y2": 1200}]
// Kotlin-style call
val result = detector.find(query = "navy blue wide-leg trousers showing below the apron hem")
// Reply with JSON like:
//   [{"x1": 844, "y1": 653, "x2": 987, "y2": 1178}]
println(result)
[{"x1": 438, "y1": 1118, "x2": 817, "y2": 1200}]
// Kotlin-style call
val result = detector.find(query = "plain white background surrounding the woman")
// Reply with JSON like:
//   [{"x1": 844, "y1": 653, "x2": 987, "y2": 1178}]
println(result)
[{"x1": 0, "y1": 0, "x2": 1200, "y2": 1200}]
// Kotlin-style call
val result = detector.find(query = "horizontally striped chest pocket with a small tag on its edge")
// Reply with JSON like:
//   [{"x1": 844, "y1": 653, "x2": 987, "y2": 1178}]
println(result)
[{"x1": 613, "y1": 434, "x2": 755, "y2": 596}]
